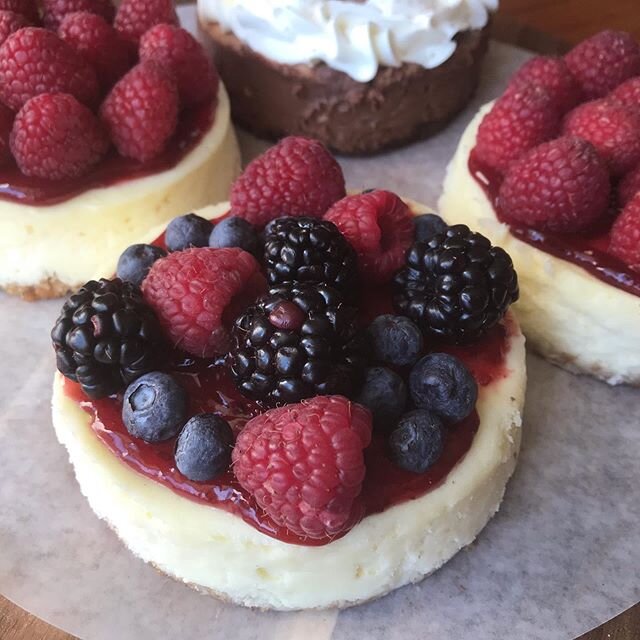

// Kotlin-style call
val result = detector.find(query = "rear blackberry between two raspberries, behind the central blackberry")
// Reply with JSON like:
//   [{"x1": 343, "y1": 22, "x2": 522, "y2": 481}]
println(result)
[{"x1": 264, "y1": 217, "x2": 357, "y2": 291}]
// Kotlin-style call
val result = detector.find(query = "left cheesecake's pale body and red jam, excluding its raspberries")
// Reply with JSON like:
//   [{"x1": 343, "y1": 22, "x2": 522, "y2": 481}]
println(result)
[{"x1": 0, "y1": 85, "x2": 240, "y2": 300}]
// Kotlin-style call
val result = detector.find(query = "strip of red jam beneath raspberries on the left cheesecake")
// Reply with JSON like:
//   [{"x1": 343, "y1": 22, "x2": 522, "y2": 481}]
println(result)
[{"x1": 0, "y1": 102, "x2": 215, "y2": 206}]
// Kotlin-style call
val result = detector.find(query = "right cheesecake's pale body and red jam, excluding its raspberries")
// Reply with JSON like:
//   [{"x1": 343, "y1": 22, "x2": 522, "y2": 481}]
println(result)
[{"x1": 439, "y1": 105, "x2": 640, "y2": 385}]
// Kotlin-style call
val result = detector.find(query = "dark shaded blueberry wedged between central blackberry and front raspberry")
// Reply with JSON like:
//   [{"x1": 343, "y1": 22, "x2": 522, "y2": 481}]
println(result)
[{"x1": 356, "y1": 367, "x2": 408, "y2": 432}]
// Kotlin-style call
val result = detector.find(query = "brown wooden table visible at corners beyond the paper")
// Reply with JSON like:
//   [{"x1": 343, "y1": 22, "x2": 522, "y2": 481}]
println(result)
[{"x1": 0, "y1": 0, "x2": 640, "y2": 640}]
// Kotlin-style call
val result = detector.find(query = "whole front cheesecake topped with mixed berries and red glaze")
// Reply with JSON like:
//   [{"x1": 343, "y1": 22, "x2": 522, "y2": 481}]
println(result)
[{"x1": 51, "y1": 138, "x2": 526, "y2": 610}]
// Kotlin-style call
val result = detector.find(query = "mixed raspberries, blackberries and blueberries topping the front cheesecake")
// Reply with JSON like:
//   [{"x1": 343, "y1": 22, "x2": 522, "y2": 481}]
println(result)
[{"x1": 52, "y1": 138, "x2": 518, "y2": 538}]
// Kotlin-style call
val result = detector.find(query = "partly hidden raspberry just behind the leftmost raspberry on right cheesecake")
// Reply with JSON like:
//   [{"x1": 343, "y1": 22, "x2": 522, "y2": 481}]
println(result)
[{"x1": 507, "y1": 56, "x2": 581, "y2": 113}]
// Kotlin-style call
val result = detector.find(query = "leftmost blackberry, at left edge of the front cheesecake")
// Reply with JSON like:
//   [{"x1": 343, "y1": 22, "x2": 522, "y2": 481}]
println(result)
[{"x1": 51, "y1": 278, "x2": 164, "y2": 398}]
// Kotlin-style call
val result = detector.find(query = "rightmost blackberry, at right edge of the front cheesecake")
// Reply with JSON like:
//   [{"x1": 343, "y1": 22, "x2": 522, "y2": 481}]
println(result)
[{"x1": 394, "y1": 224, "x2": 518, "y2": 343}]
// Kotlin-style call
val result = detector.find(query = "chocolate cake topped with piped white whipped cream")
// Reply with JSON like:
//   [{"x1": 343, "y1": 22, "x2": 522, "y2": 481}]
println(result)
[{"x1": 198, "y1": 0, "x2": 498, "y2": 154}]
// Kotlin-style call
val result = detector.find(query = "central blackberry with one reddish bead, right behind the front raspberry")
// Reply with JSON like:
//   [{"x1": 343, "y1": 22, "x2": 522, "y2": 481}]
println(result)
[{"x1": 229, "y1": 284, "x2": 366, "y2": 405}]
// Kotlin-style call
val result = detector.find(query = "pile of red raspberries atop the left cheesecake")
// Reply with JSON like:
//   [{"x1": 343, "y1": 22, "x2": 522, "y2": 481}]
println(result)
[{"x1": 0, "y1": 0, "x2": 218, "y2": 180}]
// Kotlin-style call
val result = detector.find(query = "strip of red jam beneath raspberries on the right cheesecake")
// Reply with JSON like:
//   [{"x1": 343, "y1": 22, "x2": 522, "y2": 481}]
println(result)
[{"x1": 469, "y1": 150, "x2": 640, "y2": 296}]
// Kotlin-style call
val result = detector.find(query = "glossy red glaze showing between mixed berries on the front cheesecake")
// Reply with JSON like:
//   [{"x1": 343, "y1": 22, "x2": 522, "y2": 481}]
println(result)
[{"x1": 64, "y1": 222, "x2": 517, "y2": 546}]
